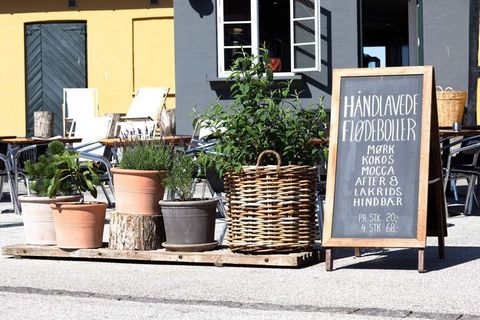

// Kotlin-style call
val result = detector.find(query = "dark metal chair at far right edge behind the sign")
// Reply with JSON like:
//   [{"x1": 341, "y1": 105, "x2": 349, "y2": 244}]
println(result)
[{"x1": 442, "y1": 136, "x2": 480, "y2": 215}]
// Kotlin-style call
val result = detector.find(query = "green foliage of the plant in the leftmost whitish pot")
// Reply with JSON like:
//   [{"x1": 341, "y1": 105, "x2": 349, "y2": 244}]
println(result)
[{"x1": 25, "y1": 141, "x2": 75, "y2": 197}]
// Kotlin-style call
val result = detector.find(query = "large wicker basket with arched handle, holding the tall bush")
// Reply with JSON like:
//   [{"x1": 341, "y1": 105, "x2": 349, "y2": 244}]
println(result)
[{"x1": 225, "y1": 150, "x2": 316, "y2": 253}]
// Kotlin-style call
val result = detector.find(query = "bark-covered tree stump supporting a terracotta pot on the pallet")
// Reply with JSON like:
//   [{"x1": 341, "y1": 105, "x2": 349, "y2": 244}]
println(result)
[{"x1": 108, "y1": 212, "x2": 165, "y2": 250}]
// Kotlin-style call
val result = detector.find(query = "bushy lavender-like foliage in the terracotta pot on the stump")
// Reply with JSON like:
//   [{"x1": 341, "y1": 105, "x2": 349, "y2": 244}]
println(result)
[{"x1": 120, "y1": 140, "x2": 173, "y2": 171}]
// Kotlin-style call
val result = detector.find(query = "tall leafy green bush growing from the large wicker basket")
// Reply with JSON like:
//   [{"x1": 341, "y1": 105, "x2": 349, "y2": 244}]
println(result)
[{"x1": 199, "y1": 49, "x2": 327, "y2": 173}]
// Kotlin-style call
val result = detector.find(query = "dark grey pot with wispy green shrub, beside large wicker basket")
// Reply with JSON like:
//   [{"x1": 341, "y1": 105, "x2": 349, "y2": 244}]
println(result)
[{"x1": 159, "y1": 153, "x2": 218, "y2": 251}]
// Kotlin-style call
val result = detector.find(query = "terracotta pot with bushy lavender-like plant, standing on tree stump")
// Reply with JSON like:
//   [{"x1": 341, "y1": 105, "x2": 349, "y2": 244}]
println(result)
[{"x1": 112, "y1": 140, "x2": 172, "y2": 215}]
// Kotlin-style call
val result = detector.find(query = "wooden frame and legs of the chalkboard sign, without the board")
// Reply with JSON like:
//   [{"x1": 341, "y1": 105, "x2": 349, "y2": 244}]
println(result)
[{"x1": 322, "y1": 66, "x2": 446, "y2": 272}]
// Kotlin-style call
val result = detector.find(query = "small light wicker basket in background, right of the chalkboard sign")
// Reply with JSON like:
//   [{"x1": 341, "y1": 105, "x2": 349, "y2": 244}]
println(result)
[{"x1": 437, "y1": 87, "x2": 467, "y2": 127}]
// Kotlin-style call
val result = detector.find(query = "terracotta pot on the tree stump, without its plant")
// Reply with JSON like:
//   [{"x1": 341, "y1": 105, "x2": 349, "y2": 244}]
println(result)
[{"x1": 112, "y1": 168, "x2": 166, "y2": 216}]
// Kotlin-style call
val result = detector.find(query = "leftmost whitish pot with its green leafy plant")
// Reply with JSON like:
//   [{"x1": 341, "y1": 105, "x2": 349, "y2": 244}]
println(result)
[{"x1": 18, "y1": 141, "x2": 81, "y2": 245}]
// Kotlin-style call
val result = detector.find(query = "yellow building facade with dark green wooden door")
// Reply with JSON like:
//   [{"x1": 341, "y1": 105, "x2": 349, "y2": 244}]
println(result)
[{"x1": 0, "y1": 0, "x2": 175, "y2": 136}]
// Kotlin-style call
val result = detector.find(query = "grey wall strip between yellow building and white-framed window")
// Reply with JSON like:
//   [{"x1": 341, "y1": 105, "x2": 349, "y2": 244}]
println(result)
[{"x1": 173, "y1": 0, "x2": 217, "y2": 134}]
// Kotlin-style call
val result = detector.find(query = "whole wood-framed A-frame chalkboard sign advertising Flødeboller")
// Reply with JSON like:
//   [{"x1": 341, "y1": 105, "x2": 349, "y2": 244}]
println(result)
[{"x1": 322, "y1": 66, "x2": 446, "y2": 272}]
